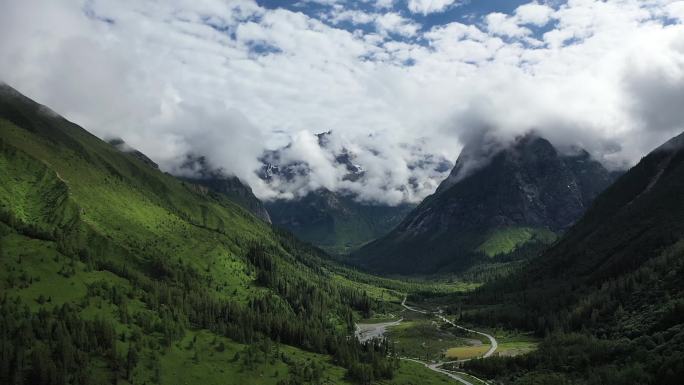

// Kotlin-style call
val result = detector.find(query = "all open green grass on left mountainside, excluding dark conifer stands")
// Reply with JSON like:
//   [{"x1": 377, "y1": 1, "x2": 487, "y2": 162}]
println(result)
[{"x1": 0, "y1": 85, "x2": 468, "y2": 384}]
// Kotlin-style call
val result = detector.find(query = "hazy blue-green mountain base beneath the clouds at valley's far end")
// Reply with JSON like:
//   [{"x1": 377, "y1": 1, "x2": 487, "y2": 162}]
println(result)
[{"x1": 266, "y1": 189, "x2": 413, "y2": 254}]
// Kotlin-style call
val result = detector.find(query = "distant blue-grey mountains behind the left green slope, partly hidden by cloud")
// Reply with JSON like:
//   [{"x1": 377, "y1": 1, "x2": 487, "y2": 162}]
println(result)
[{"x1": 108, "y1": 126, "x2": 422, "y2": 254}]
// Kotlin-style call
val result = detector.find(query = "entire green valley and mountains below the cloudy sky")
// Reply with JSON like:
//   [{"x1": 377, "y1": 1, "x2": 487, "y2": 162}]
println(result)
[{"x1": 0, "y1": 48, "x2": 684, "y2": 385}]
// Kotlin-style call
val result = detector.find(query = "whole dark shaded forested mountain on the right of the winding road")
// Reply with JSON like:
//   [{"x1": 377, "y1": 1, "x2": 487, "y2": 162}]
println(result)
[{"x1": 462, "y1": 134, "x2": 684, "y2": 385}]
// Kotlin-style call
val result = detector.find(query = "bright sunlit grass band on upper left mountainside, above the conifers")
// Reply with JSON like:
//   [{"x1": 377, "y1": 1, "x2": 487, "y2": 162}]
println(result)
[{"x1": 0, "y1": 115, "x2": 260, "y2": 295}]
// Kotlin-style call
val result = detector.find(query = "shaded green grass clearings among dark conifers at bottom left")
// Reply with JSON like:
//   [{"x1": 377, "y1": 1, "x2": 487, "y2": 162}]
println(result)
[{"x1": 0, "y1": 225, "x2": 347, "y2": 385}]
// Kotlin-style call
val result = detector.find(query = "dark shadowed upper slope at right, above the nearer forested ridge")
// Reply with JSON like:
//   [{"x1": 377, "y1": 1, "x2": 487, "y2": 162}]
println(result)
[{"x1": 540, "y1": 135, "x2": 684, "y2": 279}]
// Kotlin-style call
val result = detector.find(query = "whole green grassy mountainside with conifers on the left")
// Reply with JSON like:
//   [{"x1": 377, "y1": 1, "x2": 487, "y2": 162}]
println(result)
[{"x1": 0, "y1": 84, "x2": 416, "y2": 385}]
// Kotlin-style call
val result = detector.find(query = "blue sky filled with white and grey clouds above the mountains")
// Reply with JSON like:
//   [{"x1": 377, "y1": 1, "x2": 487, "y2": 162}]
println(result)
[{"x1": 0, "y1": 0, "x2": 684, "y2": 205}]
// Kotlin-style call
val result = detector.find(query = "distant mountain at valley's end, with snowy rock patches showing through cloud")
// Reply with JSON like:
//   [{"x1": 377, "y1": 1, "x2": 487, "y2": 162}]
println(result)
[{"x1": 259, "y1": 132, "x2": 427, "y2": 254}]
